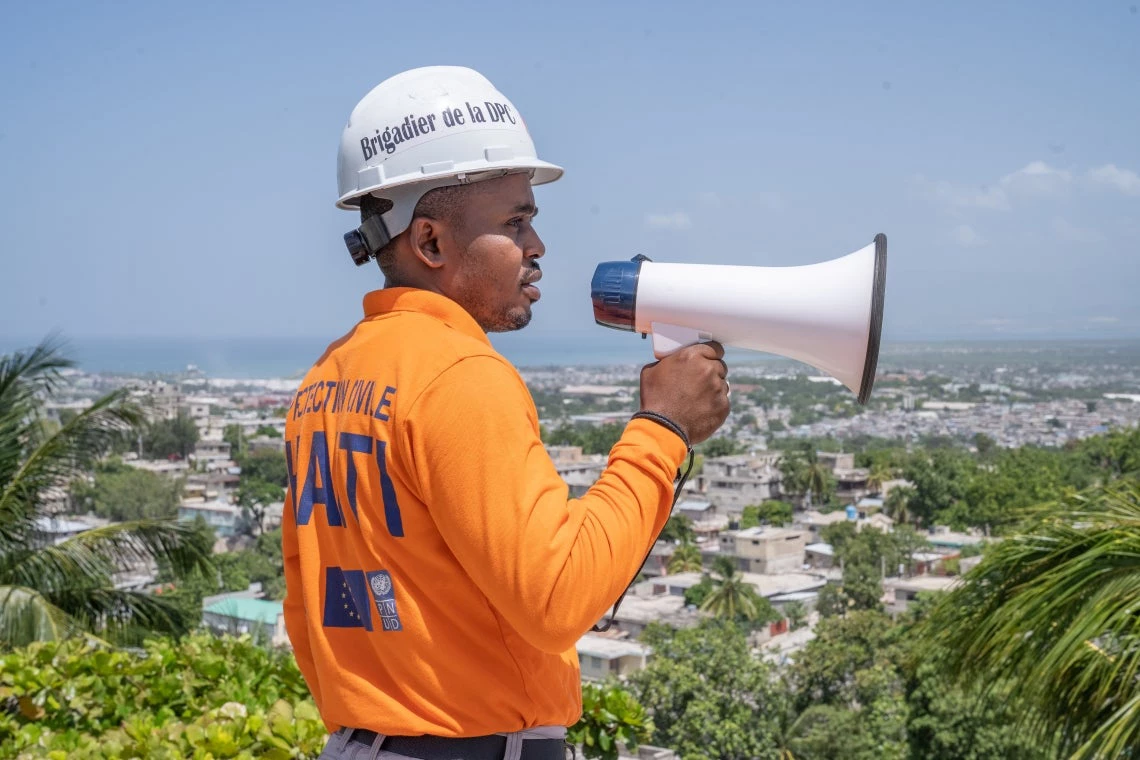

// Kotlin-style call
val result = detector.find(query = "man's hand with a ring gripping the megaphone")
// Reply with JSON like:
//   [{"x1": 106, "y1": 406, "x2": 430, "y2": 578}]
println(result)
[{"x1": 641, "y1": 343, "x2": 728, "y2": 446}]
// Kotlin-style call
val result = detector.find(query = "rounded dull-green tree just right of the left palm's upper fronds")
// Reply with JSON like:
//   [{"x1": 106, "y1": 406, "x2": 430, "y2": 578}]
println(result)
[{"x1": 72, "y1": 459, "x2": 182, "y2": 522}]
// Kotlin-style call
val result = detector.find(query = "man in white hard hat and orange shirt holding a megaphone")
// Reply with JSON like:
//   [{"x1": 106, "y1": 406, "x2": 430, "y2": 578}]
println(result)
[{"x1": 282, "y1": 67, "x2": 728, "y2": 760}]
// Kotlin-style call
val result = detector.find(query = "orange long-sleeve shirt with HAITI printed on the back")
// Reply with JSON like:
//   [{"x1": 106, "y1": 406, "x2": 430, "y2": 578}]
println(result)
[{"x1": 282, "y1": 288, "x2": 685, "y2": 736}]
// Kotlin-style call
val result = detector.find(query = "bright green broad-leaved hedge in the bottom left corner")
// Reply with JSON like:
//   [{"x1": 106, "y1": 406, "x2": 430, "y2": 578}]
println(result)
[{"x1": 0, "y1": 635, "x2": 327, "y2": 760}]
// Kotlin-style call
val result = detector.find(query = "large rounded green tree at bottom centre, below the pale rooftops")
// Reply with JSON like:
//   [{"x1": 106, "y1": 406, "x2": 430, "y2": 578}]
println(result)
[{"x1": 629, "y1": 620, "x2": 785, "y2": 759}]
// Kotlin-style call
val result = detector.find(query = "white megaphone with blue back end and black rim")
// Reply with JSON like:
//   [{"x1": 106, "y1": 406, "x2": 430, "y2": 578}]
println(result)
[{"x1": 591, "y1": 234, "x2": 887, "y2": 403}]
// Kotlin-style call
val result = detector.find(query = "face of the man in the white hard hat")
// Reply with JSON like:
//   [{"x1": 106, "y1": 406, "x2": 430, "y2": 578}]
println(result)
[{"x1": 442, "y1": 174, "x2": 546, "y2": 333}]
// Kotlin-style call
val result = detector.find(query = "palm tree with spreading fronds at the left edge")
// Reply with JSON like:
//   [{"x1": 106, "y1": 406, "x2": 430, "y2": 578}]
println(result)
[{"x1": 0, "y1": 343, "x2": 209, "y2": 648}]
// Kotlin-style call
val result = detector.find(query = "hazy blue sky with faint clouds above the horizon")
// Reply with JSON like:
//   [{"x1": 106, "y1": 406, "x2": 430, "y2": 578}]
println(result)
[{"x1": 0, "y1": 0, "x2": 1140, "y2": 362}]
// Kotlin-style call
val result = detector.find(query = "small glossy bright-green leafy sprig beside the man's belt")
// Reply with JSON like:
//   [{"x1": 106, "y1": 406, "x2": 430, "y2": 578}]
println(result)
[{"x1": 567, "y1": 683, "x2": 653, "y2": 760}]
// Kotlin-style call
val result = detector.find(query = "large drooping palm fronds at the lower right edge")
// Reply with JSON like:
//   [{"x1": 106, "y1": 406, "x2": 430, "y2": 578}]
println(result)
[{"x1": 926, "y1": 480, "x2": 1140, "y2": 758}]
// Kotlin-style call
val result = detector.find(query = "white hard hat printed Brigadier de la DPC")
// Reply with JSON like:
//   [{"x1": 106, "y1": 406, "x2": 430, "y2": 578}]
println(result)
[{"x1": 336, "y1": 66, "x2": 562, "y2": 262}]
